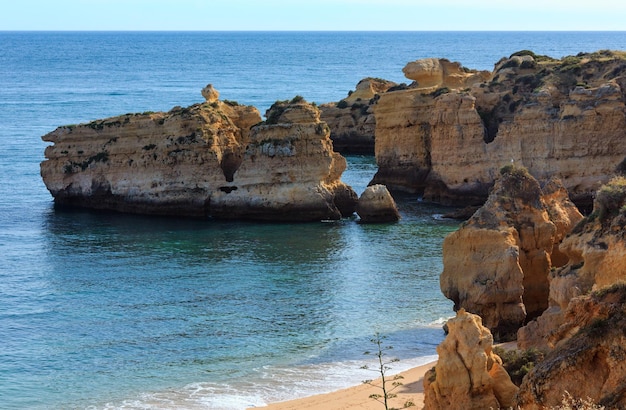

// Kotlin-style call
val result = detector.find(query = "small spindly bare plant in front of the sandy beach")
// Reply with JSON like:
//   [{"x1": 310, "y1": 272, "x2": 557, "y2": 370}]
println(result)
[{"x1": 361, "y1": 332, "x2": 415, "y2": 410}]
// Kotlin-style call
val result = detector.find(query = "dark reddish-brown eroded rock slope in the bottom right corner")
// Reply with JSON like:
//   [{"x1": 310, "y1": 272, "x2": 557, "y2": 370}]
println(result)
[{"x1": 518, "y1": 282, "x2": 626, "y2": 410}]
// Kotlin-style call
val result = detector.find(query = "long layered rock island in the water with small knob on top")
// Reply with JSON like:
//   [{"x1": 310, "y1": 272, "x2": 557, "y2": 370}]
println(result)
[{"x1": 41, "y1": 85, "x2": 357, "y2": 221}]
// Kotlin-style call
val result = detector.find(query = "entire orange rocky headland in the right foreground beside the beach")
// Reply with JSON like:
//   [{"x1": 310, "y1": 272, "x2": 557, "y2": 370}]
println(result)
[{"x1": 432, "y1": 166, "x2": 626, "y2": 410}]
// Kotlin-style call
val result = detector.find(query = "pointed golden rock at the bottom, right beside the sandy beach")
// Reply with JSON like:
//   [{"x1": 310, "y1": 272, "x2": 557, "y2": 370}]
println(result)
[{"x1": 424, "y1": 309, "x2": 518, "y2": 410}]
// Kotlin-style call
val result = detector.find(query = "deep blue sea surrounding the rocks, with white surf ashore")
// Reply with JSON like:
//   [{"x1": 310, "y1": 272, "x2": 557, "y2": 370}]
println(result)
[{"x1": 0, "y1": 32, "x2": 626, "y2": 409}]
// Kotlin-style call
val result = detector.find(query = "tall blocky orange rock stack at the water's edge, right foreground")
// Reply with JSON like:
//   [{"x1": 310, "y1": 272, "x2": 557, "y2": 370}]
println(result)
[{"x1": 440, "y1": 165, "x2": 582, "y2": 340}]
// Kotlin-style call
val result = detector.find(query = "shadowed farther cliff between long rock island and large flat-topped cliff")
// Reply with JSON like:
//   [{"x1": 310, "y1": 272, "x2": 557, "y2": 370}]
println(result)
[{"x1": 320, "y1": 78, "x2": 397, "y2": 155}]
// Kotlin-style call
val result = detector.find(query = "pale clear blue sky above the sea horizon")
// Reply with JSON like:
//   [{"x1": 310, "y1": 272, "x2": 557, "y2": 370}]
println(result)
[{"x1": 0, "y1": 0, "x2": 626, "y2": 31}]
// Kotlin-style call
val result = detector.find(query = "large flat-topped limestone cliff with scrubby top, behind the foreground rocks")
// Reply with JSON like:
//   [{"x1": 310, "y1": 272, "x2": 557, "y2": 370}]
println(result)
[{"x1": 372, "y1": 51, "x2": 626, "y2": 207}]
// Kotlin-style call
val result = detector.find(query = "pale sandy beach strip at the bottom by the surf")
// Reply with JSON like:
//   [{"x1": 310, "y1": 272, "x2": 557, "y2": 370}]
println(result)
[{"x1": 251, "y1": 362, "x2": 436, "y2": 410}]
